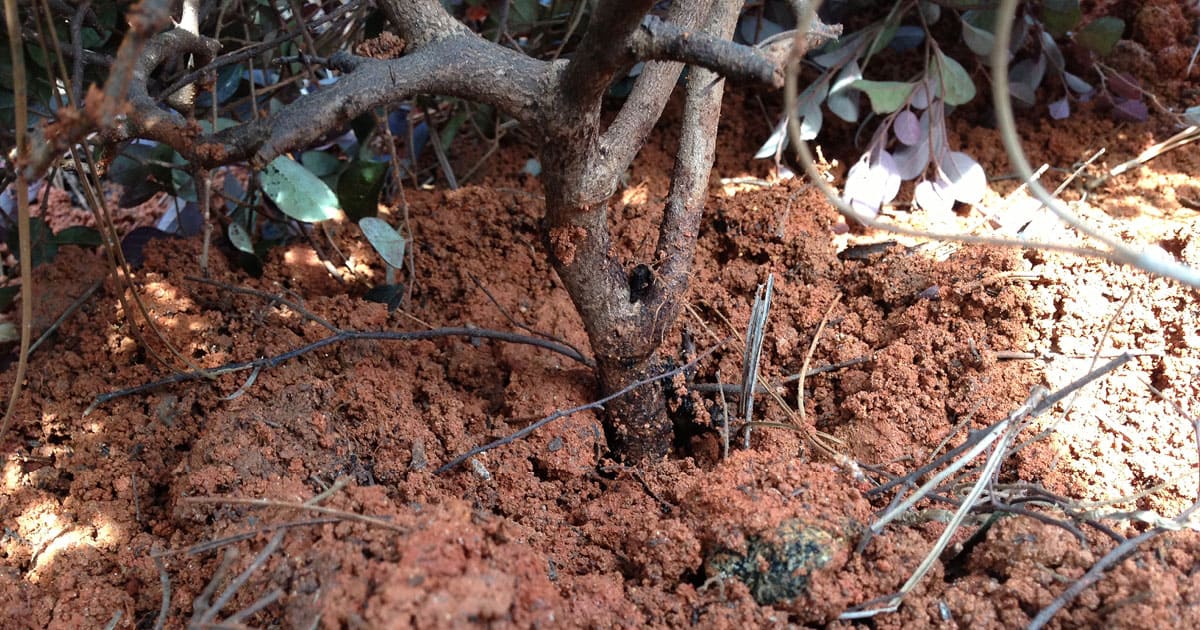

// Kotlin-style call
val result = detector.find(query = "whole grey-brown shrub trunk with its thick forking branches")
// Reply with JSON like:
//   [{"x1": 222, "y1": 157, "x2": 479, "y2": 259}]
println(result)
[{"x1": 26, "y1": 0, "x2": 825, "y2": 461}]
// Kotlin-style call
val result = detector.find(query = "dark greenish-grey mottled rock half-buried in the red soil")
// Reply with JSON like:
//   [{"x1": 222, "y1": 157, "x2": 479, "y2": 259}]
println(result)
[{"x1": 704, "y1": 520, "x2": 841, "y2": 606}]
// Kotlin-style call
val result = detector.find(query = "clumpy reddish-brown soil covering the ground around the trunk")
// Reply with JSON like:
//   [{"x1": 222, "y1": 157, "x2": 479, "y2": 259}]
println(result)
[{"x1": 0, "y1": 9, "x2": 1200, "y2": 628}]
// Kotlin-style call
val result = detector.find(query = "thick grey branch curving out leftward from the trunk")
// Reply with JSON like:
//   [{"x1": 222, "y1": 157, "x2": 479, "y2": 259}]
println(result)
[{"x1": 107, "y1": 29, "x2": 550, "y2": 168}]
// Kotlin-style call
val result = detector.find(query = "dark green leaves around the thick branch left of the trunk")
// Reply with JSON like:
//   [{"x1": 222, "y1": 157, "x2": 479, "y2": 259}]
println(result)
[{"x1": 0, "y1": 0, "x2": 604, "y2": 300}]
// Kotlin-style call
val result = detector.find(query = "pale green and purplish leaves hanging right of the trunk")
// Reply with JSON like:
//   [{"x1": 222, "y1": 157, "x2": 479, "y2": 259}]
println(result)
[{"x1": 756, "y1": 0, "x2": 1148, "y2": 216}]
